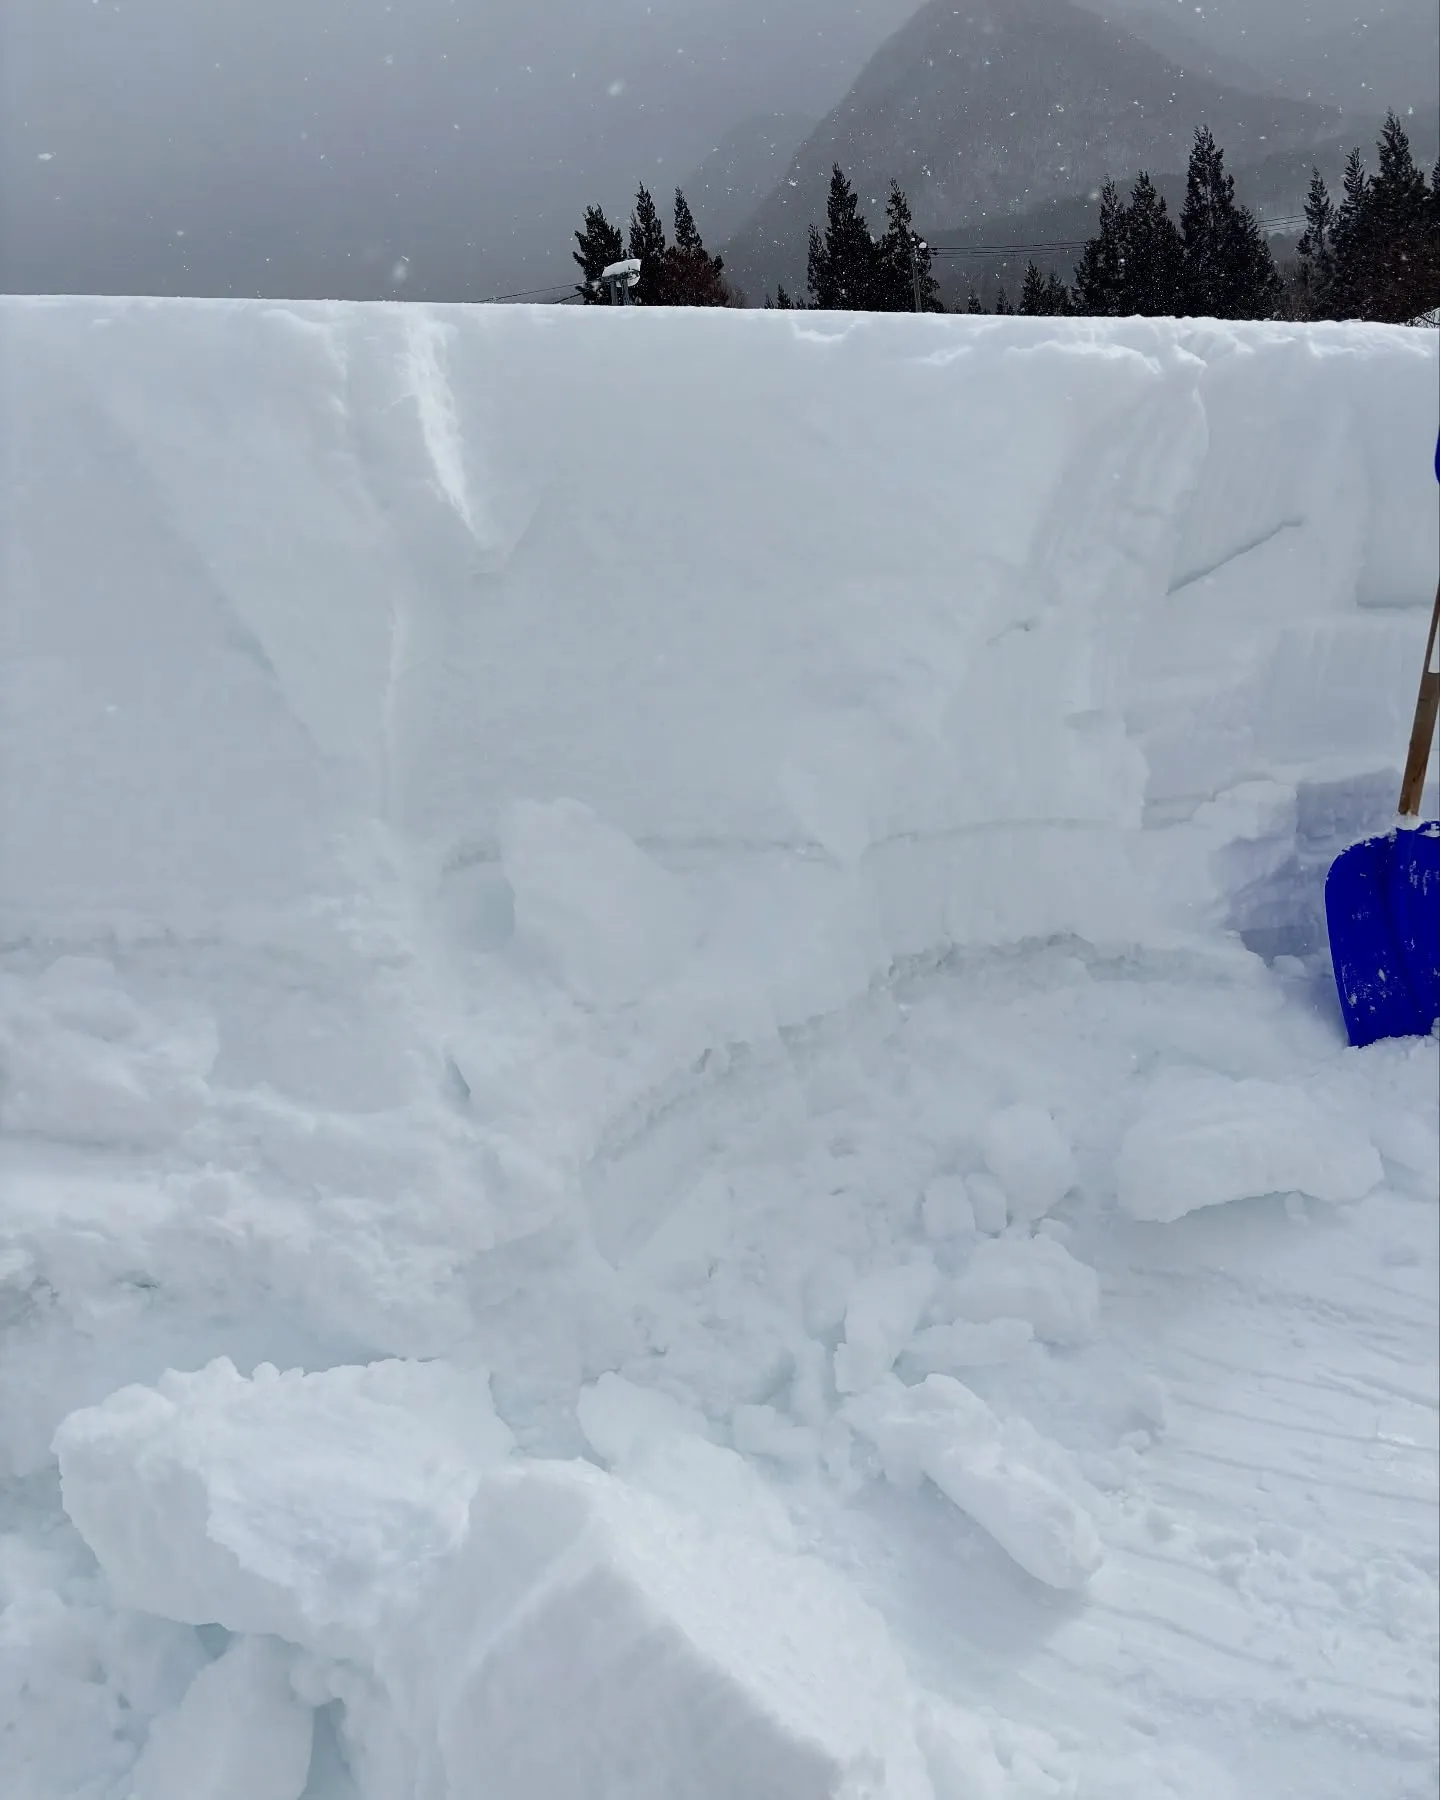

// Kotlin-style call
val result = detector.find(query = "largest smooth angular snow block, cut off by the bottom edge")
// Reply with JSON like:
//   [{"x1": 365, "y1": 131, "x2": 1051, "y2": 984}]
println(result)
[{"x1": 380, "y1": 1463, "x2": 932, "y2": 1800}]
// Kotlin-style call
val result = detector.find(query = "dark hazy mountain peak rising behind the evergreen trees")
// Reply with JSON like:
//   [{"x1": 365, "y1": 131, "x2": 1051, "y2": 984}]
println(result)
[{"x1": 725, "y1": 0, "x2": 1337, "y2": 297}]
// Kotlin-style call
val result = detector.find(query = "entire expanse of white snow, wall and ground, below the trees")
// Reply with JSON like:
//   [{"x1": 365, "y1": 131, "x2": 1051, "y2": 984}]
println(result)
[{"x1": 0, "y1": 301, "x2": 1440, "y2": 1800}]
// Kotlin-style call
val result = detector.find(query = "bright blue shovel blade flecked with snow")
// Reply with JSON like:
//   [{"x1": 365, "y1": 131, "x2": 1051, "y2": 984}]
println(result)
[{"x1": 1325, "y1": 823, "x2": 1440, "y2": 1046}]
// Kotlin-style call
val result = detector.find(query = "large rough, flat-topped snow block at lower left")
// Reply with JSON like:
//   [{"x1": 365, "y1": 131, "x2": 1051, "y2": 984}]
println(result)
[{"x1": 54, "y1": 1357, "x2": 513, "y2": 1656}]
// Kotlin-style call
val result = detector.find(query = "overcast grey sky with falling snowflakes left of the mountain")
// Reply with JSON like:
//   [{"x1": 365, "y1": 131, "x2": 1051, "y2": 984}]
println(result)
[{"x1": 0, "y1": 0, "x2": 1396, "y2": 297}]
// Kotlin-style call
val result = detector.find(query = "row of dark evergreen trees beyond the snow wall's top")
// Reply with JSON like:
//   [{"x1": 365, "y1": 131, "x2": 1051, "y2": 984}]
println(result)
[{"x1": 574, "y1": 112, "x2": 1440, "y2": 324}]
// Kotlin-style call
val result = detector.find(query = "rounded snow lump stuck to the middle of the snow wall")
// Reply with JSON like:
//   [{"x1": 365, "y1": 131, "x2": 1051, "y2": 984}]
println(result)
[{"x1": 500, "y1": 799, "x2": 698, "y2": 1006}]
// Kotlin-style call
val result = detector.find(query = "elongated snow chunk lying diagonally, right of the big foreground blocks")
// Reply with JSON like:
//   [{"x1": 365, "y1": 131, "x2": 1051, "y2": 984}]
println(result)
[{"x1": 846, "y1": 1375, "x2": 1102, "y2": 1588}]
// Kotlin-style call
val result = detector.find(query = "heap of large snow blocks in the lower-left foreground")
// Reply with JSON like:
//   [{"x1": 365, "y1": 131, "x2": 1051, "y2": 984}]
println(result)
[{"x1": 56, "y1": 1361, "x2": 932, "y2": 1800}]
